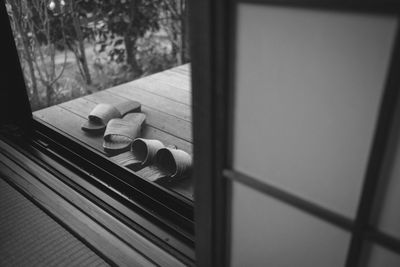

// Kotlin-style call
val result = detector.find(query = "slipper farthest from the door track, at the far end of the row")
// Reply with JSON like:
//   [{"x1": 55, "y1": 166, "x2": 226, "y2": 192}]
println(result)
[{"x1": 81, "y1": 100, "x2": 141, "y2": 134}]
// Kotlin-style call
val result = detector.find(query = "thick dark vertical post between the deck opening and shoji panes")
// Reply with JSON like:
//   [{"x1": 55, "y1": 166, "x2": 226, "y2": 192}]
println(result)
[{"x1": 189, "y1": 0, "x2": 234, "y2": 267}]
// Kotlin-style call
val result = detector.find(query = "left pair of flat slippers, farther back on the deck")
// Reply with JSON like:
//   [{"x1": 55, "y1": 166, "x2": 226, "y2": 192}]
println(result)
[{"x1": 81, "y1": 100, "x2": 146, "y2": 154}]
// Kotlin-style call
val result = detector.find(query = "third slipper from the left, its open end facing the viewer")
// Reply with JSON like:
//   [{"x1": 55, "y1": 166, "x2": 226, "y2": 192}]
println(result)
[{"x1": 111, "y1": 138, "x2": 165, "y2": 169}]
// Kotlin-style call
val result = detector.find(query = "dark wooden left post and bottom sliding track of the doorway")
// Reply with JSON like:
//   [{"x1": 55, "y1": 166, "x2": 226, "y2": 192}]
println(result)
[{"x1": 0, "y1": 2, "x2": 195, "y2": 263}]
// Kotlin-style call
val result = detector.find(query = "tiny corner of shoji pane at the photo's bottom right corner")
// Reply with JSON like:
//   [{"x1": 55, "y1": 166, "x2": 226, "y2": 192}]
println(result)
[{"x1": 367, "y1": 245, "x2": 400, "y2": 267}]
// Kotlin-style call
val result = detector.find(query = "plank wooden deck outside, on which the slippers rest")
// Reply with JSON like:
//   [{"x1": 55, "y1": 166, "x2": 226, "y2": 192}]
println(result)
[{"x1": 33, "y1": 64, "x2": 193, "y2": 200}]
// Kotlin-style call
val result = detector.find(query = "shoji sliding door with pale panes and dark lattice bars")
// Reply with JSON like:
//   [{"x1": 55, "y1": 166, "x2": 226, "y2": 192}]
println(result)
[{"x1": 224, "y1": 1, "x2": 400, "y2": 266}]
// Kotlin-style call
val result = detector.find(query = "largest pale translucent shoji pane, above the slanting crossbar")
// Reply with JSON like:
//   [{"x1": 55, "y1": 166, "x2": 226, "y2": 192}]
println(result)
[{"x1": 233, "y1": 4, "x2": 397, "y2": 216}]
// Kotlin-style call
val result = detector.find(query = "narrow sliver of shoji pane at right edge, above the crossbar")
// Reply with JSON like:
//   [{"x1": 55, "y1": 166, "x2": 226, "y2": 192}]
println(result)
[{"x1": 375, "y1": 104, "x2": 400, "y2": 239}]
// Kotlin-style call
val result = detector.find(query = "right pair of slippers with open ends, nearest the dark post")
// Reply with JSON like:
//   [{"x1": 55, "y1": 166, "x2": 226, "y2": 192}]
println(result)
[{"x1": 111, "y1": 138, "x2": 193, "y2": 182}]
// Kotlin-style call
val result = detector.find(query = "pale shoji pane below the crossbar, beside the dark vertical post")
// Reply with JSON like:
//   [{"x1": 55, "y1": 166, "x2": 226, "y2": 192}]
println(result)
[{"x1": 231, "y1": 183, "x2": 350, "y2": 267}]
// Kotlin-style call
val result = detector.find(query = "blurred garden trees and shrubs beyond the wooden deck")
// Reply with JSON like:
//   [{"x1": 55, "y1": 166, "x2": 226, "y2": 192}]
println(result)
[{"x1": 5, "y1": 0, "x2": 189, "y2": 109}]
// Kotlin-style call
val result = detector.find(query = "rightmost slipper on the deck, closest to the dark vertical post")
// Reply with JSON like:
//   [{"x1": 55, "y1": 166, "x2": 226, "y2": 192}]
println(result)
[{"x1": 136, "y1": 147, "x2": 193, "y2": 182}]
